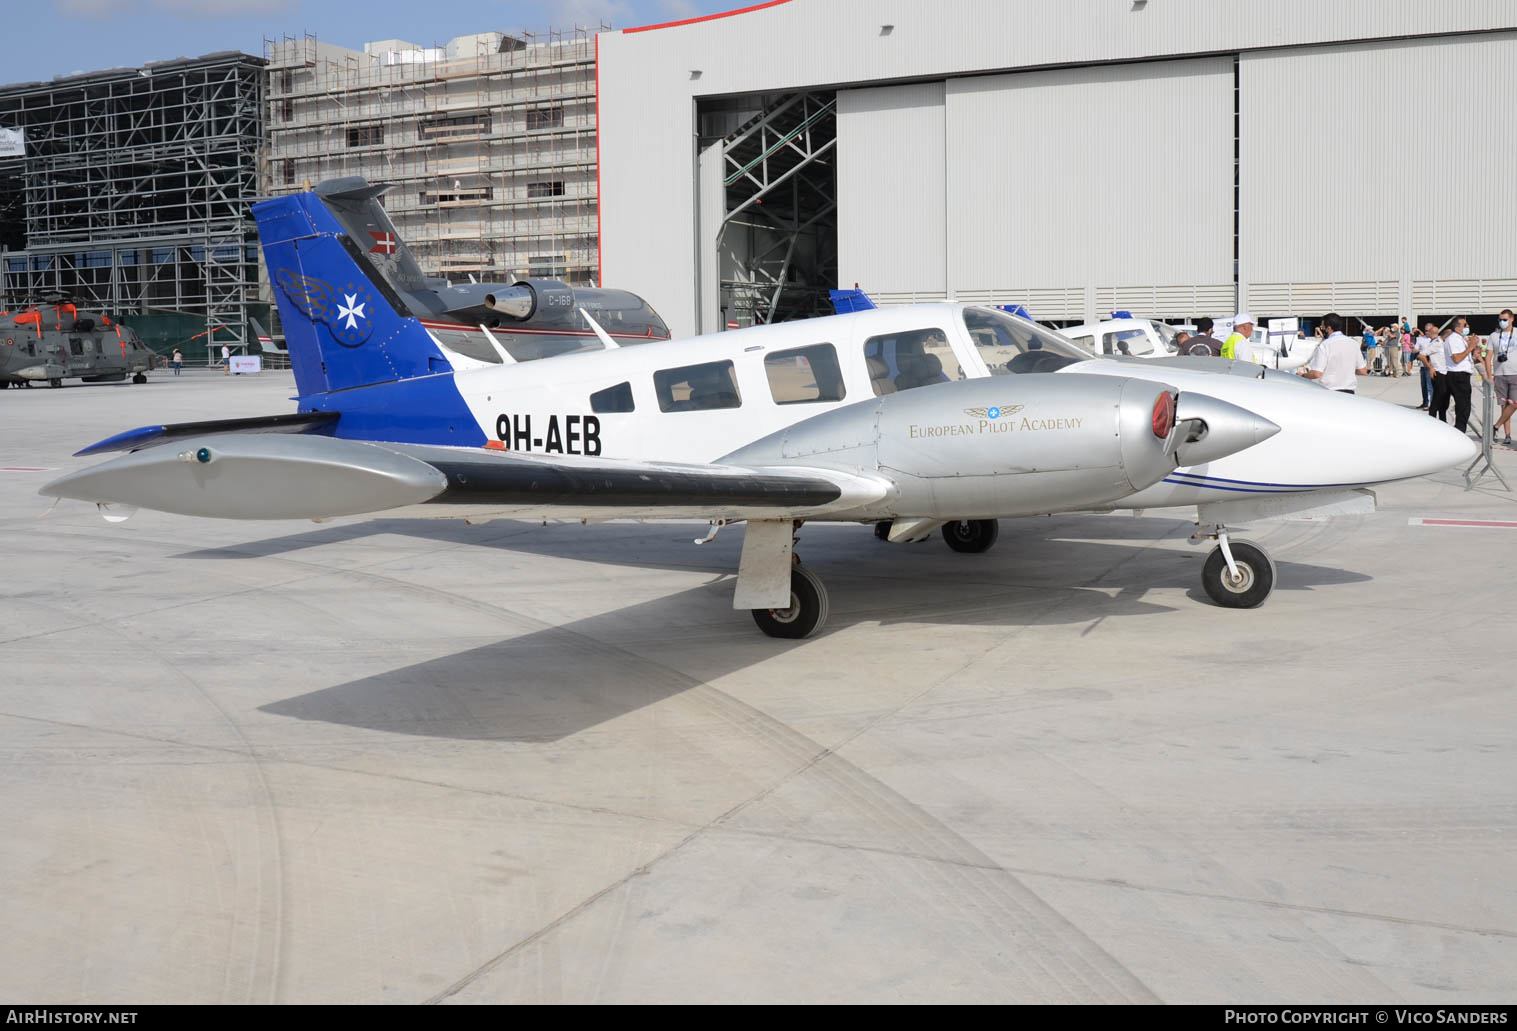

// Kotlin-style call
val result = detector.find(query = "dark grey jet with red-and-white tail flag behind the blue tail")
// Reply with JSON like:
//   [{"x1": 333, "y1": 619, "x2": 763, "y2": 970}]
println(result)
[{"x1": 304, "y1": 176, "x2": 669, "y2": 364}]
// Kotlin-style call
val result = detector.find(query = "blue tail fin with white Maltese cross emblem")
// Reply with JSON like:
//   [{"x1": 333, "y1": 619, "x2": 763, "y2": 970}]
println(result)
[{"x1": 253, "y1": 183, "x2": 454, "y2": 397}]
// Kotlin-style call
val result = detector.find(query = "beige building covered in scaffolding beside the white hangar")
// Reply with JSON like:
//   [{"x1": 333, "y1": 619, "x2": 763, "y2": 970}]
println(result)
[{"x1": 264, "y1": 24, "x2": 608, "y2": 284}]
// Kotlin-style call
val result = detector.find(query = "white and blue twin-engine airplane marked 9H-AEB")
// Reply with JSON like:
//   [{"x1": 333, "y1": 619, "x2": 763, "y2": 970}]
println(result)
[{"x1": 41, "y1": 183, "x2": 1473, "y2": 638}]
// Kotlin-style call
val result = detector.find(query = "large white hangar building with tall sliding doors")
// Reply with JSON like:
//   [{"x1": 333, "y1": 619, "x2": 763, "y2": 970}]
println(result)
[{"x1": 598, "y1": 0, "x2": 1517, "y2": 335}]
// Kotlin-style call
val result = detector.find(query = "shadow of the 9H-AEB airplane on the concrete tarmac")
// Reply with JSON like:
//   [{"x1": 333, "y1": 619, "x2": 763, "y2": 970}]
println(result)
[{"x1": 227, "y1": 517, "x2": 1370, "y2": 741}]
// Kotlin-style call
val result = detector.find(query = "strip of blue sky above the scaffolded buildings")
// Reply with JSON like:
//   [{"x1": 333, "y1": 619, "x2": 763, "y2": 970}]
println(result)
[{"x1": 0, "y1": 0, "x2": 752, "y2": 83}]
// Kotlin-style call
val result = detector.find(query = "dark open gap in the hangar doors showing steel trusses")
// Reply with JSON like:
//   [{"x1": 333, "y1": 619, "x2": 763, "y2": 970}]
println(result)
[{"x1": 696, "y1": 92, "x2": 837, "y2": 332}]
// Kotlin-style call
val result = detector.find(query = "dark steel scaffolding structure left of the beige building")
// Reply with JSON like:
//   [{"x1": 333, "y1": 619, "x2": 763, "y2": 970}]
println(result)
[{"x1": 0, "y1": 52, "x2": 264, "y2": 354}]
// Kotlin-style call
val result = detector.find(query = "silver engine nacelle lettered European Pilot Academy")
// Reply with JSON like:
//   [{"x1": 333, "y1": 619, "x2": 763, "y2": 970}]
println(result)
[{"x1": 722, "y1": 376, "x2": 1279, "y2": 519}]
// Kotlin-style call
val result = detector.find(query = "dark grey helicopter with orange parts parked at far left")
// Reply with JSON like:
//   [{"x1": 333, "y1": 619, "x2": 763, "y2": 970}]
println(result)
[{"x1": 0, "y1": 296, "x2": 159, "y2": 387}]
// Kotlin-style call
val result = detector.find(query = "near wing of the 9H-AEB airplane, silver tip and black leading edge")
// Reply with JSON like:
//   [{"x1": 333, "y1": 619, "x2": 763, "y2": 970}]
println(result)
[{"x1": 39, "y1": 428, "x2": 889, "y2": 520}]
